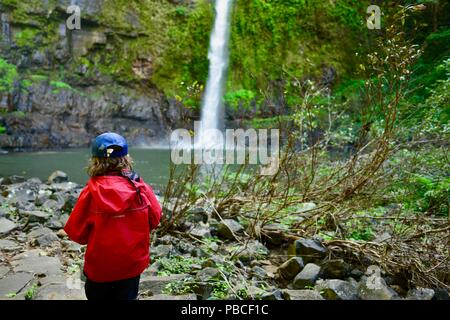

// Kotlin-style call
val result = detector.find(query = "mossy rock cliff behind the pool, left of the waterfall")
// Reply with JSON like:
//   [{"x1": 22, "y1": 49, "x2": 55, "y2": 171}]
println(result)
[{"x1": 0, "y1": 0, "x2": 186, "y2": 149}]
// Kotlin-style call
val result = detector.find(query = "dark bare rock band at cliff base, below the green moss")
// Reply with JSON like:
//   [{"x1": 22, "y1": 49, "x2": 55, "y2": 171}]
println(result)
[{"x1": 0, "y1": 82, "x2": 169, "y2": 149}]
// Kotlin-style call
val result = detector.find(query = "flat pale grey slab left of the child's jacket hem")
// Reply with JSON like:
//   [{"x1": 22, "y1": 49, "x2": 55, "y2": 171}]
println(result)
[{"x1": 11, "y1": 249, "x2": 62, "y2": 276}]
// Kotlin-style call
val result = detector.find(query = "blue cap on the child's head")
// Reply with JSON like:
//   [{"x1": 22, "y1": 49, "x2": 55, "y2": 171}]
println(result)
[{"x1": 92, "y1": 132, "x2": 128, "y2": 158}]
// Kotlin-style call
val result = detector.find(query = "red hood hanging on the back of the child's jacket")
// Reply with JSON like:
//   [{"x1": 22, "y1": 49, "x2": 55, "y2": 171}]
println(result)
[{"x1": 88, "y1": 176, "x2": 148, "y2": 214}]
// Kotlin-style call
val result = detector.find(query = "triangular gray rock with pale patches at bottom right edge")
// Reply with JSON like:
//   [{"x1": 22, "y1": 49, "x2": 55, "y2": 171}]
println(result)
[{"x1": 358, "y1": 274, "x2": 398, "y2": 300}]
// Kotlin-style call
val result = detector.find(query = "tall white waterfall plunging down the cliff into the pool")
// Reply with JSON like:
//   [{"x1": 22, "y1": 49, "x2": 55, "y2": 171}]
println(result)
[{"x1": 196, "y1": 0, "x2": 233, "y2": 148}]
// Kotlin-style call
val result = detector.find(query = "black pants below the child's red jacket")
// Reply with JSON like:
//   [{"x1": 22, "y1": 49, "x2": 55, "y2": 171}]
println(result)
[{"x1": 84, "y1": 275, "x2": 141, "y2": 300}]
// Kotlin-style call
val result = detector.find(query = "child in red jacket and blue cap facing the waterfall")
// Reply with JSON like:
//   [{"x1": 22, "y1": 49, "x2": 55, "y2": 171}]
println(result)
[{"x1": 64, "y1": 132, "x2": 161, "y2": 300}]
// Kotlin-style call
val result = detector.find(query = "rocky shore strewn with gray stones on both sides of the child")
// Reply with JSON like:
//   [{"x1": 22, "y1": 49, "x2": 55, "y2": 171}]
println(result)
[{"x1": 0, "y1": 171, "x2": 448, "y2": 300}]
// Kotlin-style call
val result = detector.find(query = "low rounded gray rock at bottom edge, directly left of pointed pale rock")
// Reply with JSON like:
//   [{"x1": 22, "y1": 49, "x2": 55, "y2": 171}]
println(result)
[{"x1": 315, "y1": 279, "x2": 358, "y2": 300}]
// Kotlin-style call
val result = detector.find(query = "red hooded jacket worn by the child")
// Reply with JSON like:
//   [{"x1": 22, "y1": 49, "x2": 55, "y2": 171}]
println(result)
[{"x1": 64, "y1": 175, "x2": 161, "y2": 282}]
